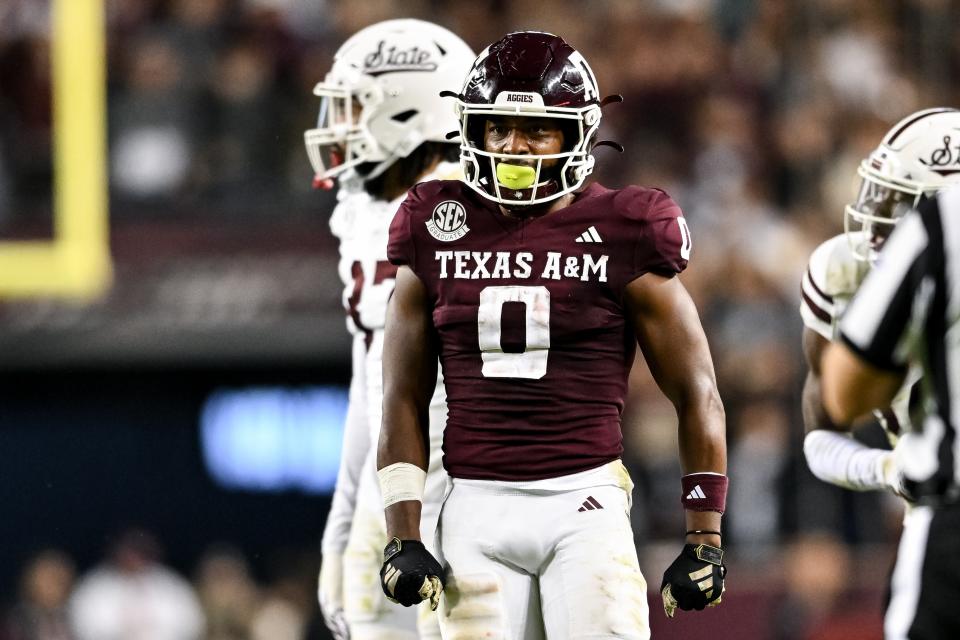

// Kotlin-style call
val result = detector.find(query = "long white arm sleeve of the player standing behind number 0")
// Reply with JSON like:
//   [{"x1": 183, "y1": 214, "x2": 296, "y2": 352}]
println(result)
[{"x1": 320, "y1": 332, "x2": 371, "y2": 555}]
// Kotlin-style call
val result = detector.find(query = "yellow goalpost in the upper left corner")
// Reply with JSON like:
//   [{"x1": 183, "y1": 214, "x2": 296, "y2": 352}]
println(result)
[{"x1": 0, "y1": 0, "x2": 112, "y2": 299}]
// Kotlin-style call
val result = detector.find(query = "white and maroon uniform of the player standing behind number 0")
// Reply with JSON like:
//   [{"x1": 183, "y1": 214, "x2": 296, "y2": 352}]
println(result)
[{"x1": 322, "y1": 163, "x2": 460, "y2": 638}]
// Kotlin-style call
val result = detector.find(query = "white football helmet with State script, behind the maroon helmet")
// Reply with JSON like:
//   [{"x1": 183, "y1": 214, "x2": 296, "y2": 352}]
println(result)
[{"x1": 304, "y1": 19, "x2": 474, "y2": 189}]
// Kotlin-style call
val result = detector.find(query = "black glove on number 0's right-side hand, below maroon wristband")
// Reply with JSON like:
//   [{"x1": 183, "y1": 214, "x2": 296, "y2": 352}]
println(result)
[{"x1": 660, "y1": 544, "x2": 727, "y2": 618}]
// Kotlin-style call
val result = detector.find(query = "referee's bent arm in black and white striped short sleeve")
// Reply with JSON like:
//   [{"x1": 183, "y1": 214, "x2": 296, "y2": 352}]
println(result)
[{"x1": 823, "y1": 199, "x2": 936, "y2": 426}]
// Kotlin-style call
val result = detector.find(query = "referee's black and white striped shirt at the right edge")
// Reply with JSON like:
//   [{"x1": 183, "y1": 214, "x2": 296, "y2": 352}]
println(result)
[{"x1": 840, "y1": 188, "x2": 960, "y2": 501}]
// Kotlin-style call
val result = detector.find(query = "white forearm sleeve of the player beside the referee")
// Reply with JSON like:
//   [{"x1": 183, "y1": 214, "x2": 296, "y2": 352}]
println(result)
[{"x1": 803, "y1": 429, "x2": 898, "y2": 491}]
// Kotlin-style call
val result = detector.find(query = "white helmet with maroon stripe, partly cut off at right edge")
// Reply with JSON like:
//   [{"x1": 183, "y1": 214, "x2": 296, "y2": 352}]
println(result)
[{"x1": 843, "y1": 107, "x2": 960, "y2": 262}]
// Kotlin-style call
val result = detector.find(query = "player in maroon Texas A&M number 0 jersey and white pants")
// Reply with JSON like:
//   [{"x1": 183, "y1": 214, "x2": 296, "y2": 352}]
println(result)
[{"x1": 378, "y1": 32, "x2": 727, "y2": 640}]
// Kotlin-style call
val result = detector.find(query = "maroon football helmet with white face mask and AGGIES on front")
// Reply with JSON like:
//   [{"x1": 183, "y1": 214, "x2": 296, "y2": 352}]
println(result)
[{"x1": 456, "y1": 31, "x2": 601, "y2": 206}]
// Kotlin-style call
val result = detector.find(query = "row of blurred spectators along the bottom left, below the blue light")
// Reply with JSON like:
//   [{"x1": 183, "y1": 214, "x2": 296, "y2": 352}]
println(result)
[{"x1": 0, "y1": 529, "x2": 325, "y2": 640}]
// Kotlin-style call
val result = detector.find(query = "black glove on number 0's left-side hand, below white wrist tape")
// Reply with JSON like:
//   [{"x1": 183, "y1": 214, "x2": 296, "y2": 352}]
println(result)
[{"x1": 380, "y1": 538, "x2": 444, "y2": 611}]
